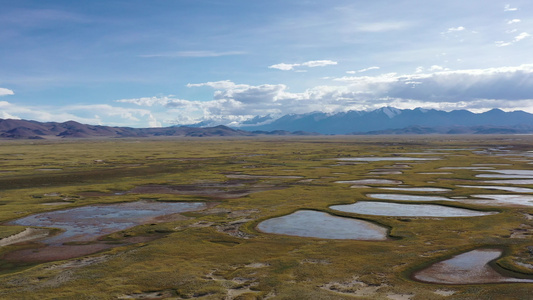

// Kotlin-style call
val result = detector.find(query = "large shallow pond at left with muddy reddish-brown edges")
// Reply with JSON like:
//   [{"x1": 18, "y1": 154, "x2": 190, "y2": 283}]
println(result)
[{"x1": 4, "y1": 201, "x2": 208, "y2": 261}]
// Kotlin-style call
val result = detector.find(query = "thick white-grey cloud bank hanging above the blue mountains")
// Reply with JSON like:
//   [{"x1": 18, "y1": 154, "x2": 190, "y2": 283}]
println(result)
[{"x1": 111, "y1": 64, "x2": 533, "y2": 126}]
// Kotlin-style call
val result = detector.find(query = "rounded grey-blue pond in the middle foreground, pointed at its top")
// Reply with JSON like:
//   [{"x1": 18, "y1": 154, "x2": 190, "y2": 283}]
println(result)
[{"x1": 257, "y1": 210, "x2": 387, "y2": 241}]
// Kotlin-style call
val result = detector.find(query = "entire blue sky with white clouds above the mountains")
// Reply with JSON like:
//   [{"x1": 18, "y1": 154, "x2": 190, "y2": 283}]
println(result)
[{"x1": 0, "y1": 0, "x2": 533, "y2": 127}]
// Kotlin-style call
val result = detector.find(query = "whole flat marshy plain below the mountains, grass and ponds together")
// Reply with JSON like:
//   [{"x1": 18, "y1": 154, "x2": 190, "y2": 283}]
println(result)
[{"x1": 0, "y1": 136, "x2": 533, "y2": 300}]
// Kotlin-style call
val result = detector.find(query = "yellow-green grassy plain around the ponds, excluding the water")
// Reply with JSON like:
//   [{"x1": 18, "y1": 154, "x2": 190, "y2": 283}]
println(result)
[{"x1": 0, "y1": 136, "x2": 533, "y2": 300}]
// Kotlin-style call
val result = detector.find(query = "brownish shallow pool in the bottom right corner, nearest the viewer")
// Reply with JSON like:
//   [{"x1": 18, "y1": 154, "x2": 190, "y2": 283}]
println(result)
[{"x1": 413, "y1": 249, "x2": 533, "y2": 284}]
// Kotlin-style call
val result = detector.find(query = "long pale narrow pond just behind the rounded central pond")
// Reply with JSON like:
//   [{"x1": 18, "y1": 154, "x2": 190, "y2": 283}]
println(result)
[{"x1": 330, "y1": 201, "x2": 496, "y2": 217}]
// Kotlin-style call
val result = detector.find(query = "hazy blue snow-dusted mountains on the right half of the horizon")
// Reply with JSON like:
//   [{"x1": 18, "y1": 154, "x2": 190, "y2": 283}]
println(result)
[{"x1": 239, "y1": 107, "x2": 533, "y2": 134}]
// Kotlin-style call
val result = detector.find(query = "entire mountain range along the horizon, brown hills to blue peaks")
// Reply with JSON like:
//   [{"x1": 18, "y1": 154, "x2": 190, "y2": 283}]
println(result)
[{"x1": 0, "y1": 107, "x2": 533, "y2": 139}]
